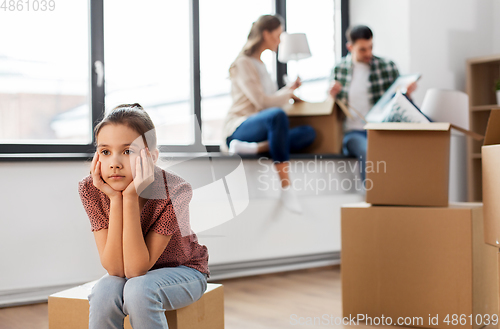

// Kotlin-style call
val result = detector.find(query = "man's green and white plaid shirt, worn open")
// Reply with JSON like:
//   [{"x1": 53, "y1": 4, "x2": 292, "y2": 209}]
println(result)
[{"x1": 330, "y1": 53, "x2": 399, "y2": 105}]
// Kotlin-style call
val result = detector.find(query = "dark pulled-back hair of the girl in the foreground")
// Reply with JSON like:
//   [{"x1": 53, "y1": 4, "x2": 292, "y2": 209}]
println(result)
[{"x1": 94, "y1": 103, "x2": 156, "y2": 150}]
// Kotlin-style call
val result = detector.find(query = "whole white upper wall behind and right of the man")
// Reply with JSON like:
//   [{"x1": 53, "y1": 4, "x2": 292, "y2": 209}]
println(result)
[{"x1": 350, "y1": 0, "x2": 500, "y2": 105}]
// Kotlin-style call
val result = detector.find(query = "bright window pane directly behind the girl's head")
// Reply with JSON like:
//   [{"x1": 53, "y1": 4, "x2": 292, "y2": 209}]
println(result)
[{"x1": 104, "y1": 0, "x2": 194, "y2": 145}]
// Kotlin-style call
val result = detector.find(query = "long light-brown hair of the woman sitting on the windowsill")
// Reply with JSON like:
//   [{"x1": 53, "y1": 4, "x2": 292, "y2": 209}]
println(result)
[{"x1": 229, "y1": 15, "x2": 284, "y2": 75}]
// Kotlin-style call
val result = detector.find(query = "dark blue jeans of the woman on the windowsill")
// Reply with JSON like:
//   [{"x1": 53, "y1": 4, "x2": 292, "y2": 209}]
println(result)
[{"x1": 226, "y1": 107, "x2": 316, "y2": 162}]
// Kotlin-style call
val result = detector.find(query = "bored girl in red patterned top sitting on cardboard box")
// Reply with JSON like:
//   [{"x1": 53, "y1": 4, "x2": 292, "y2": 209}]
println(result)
[{"x1": 79, "y1": 104, "x2": 210, "y2": 329}]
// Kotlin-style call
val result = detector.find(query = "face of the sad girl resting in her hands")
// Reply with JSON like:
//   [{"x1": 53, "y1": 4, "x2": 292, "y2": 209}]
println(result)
[{"x1": 97, "y1": 124, "x2": 145, "y2": 191}]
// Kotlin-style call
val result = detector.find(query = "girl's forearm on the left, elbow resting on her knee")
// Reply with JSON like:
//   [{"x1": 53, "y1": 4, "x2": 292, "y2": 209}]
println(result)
[{"x1": 101, "y1": 196, "x2": 125, "y2": 277}]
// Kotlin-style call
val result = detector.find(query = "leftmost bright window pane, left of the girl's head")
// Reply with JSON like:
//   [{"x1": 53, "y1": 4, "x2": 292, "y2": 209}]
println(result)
[{"x1": 0, "y1": 0, "x2": 91, "y2": 145}]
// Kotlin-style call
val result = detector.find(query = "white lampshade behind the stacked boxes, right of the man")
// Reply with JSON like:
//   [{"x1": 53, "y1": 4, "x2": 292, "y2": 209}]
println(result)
[{"x1": 421, "y1": 89, "x2": 469, "y2": 129}]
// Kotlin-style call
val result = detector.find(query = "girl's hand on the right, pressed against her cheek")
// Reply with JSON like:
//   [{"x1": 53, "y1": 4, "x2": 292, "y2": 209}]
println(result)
[{"x1": 123, "y1": 148, "x2": 155, "y2": 197}]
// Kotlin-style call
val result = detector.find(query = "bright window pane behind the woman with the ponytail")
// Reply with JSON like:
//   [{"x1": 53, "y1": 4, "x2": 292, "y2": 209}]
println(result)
[{"x1": 200, "y1": 0, "x2": 276, "y2": 144}]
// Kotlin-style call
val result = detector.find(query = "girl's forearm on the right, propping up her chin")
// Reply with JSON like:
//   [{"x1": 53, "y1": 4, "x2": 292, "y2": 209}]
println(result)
[{"x1": 123, "y1": 196, "x2": 151, "y2": 278}]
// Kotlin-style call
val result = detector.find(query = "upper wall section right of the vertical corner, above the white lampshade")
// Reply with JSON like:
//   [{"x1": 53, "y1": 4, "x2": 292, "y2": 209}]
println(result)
[{"x1": 409, "y1": 0, "x2": 500, "y2": 104}]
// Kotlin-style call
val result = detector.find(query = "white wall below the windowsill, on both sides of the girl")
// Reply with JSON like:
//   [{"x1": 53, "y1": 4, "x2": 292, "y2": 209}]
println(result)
[{"x1": 0, "y1": 159, "x2": 363, "y2": 307}]
